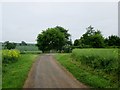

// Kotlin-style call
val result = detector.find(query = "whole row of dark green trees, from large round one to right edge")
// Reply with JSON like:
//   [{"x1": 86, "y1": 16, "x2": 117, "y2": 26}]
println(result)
[{"x1": 36, "y1": 26, "x2": 120, "y2": 53}]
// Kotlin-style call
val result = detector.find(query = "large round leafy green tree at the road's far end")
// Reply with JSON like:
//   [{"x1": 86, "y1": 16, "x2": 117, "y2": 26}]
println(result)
[{"x1": 37, "y1": 28, "x2": 66, "y2": 53}]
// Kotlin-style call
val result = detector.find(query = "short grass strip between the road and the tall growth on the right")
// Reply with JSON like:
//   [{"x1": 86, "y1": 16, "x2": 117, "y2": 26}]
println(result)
[{"x1": 55, "y1": 54, "x2": 117, "y2": 88}]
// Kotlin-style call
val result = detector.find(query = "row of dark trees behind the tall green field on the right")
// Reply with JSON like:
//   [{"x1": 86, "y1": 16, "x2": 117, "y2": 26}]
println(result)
[{"x1": 74, "y1": 26, "x2": 120, "y2": 48}]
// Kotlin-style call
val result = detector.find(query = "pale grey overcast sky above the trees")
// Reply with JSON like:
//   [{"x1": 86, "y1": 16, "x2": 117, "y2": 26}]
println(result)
[{"x1": 2, "y1": 2, "x2": 118, "y2": 43}]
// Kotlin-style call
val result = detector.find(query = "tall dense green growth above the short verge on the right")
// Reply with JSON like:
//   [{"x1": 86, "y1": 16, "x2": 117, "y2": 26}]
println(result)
[{"x1": 72, "y1": 49, "x2": 119, "y2": 75}]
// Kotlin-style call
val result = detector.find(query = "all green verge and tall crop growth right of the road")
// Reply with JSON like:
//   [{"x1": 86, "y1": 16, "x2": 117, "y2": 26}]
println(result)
[{"x1": 55, "y1": 49, "x2": 119, "y2": 88}]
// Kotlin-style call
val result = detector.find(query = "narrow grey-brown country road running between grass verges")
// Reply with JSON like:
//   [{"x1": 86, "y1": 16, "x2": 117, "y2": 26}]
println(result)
[{"x1": 23, "y1": 54, "x2": 87, "y2": 88}]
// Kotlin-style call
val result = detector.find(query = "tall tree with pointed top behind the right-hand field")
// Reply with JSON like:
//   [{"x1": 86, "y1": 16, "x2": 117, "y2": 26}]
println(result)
[{"x1": 80, "y1": 26, "x2": 104, "y2": 48}]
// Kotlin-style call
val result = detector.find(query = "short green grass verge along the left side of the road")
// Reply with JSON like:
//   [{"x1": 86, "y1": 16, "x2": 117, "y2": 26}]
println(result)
[{"x1": 2, "y1": 54, "x2": 38, "y2": 88}]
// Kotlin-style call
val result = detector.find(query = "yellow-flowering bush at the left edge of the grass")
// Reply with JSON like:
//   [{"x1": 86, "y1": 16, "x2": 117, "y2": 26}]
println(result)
[{"x1": 2, "y1": 50, "x2": 20, "y2": 63}]
